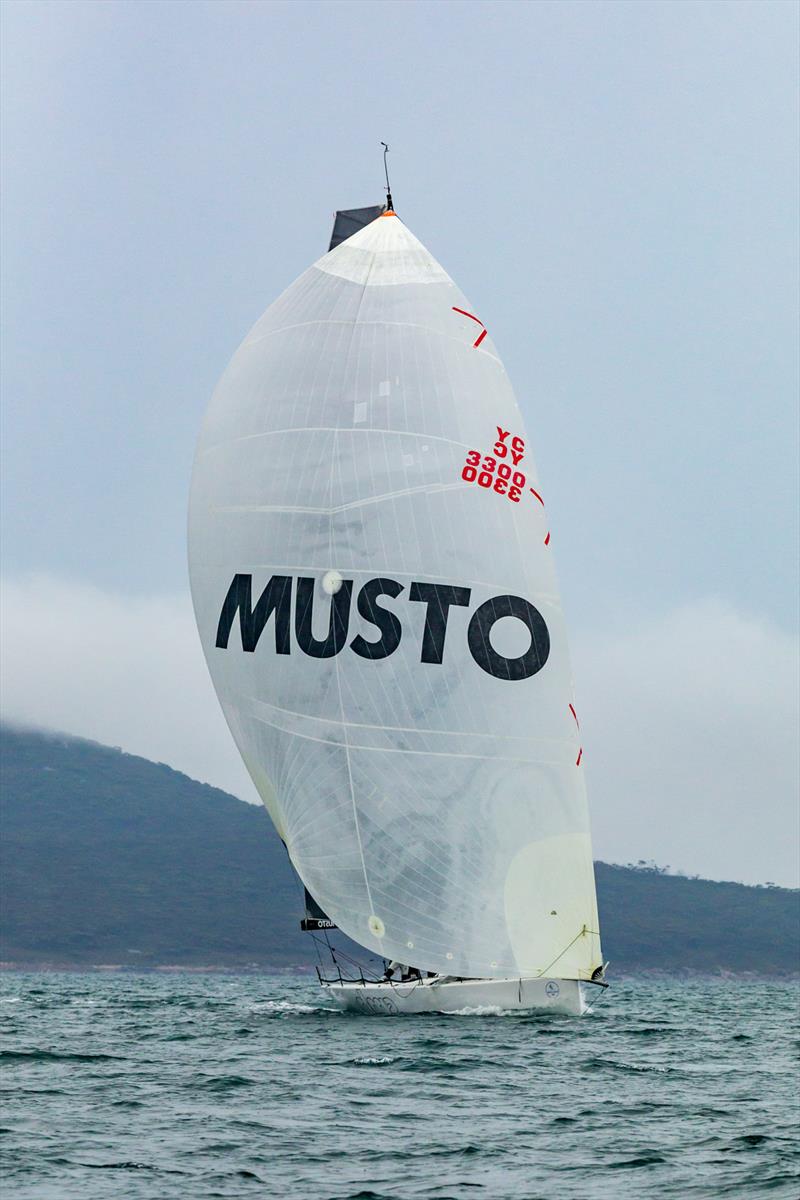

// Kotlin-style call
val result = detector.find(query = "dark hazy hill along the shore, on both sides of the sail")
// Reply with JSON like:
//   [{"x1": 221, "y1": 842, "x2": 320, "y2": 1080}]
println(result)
[{"x1": 0, "y1": 727, "x2": 800, "y2": 974}]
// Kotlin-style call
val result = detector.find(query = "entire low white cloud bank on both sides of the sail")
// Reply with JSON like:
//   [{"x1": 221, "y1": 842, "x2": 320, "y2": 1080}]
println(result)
[{"x1": 2, "y1": 575, "x2": 799, "y2": 886}]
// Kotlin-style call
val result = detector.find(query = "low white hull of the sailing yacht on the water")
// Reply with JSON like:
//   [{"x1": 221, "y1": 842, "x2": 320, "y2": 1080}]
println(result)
[{"x1": 323, "y1": 979, "x2": 589, "y2": 1016}]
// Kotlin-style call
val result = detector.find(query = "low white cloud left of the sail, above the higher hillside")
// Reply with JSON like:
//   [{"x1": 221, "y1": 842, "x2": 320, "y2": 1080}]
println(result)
[{"x1": 0, "y1": 575, "x2": 258, "y2": 800}]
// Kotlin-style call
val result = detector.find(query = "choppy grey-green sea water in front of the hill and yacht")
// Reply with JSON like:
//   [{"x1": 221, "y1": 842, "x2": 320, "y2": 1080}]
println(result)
[{"x1": 0, "y1": 973, "x2": 800, "y2": 1200}]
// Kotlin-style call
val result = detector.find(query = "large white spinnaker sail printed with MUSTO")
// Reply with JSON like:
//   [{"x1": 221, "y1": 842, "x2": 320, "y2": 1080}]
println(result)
[{"x1": 190, "y1": 214, "x2": 601, "y2": 978}]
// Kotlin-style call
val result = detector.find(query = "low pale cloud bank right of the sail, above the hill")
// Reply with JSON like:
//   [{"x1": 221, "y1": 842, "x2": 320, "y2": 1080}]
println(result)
[{"x1": 575, "y1": 601, "x2": 800, "y2": 887}]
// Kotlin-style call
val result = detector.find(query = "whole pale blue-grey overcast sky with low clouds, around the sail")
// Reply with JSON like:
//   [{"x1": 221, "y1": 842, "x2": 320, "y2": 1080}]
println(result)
[{"x1": 2, "y1": 0, "x2": 799, "y2": 884}]
